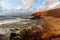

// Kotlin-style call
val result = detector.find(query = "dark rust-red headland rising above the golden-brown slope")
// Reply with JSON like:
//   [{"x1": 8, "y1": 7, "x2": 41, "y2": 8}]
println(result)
[{"x1": 32, "y1": 8, "x2": 60, "y2": 18}]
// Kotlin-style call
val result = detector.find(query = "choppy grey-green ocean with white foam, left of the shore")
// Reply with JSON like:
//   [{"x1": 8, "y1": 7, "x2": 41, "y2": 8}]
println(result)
[{"x1": 0, "y1": 16, "x2": 36, "y2": 34}]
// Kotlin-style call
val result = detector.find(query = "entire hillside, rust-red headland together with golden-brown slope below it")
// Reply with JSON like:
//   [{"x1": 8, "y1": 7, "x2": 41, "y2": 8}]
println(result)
[{"x1": 32, "y1": 8, "x2": 60, "y2": 35}]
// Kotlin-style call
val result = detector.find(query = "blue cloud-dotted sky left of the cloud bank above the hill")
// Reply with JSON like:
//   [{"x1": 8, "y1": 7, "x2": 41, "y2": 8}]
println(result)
[{"x1": 0, "y1": 0, "x2": 44, "y2": 12}]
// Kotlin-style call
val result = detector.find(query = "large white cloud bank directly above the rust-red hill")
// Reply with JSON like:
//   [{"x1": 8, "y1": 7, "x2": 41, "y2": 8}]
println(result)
[{"x1": 36, "y1": 0, "x2": 60, "y2": 11}]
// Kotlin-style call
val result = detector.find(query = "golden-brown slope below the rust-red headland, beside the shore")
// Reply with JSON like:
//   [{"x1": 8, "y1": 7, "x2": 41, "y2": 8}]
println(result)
[{"x1": 43, "y1": 16, "x2": 60, "y2": 34}]
